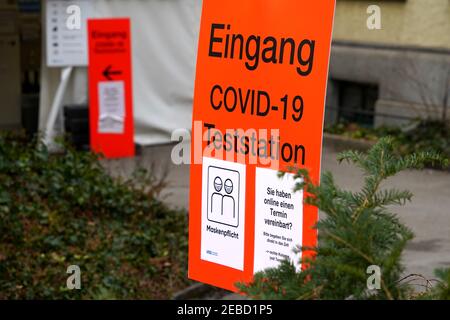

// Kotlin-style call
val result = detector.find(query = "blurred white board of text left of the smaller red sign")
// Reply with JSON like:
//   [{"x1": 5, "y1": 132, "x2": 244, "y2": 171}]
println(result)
[{"x1": 46, "y1": 0, "x2": 92, "y2": 67}]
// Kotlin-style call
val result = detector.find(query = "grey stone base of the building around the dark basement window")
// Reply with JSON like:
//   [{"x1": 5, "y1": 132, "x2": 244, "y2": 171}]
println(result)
[{"x1": 326, "y1": 43, "x2": 450, "y2": 126}]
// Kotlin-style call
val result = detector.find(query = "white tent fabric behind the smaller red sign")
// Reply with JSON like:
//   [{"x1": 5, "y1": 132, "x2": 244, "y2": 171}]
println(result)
[{"x1": 39, "y1": 0, "x2": 201, "y2": 145}]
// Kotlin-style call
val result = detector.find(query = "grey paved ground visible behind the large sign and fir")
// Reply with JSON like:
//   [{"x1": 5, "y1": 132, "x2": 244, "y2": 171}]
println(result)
[{"x1": 102, "y1": 141, "x2": 450, "y2": 277}]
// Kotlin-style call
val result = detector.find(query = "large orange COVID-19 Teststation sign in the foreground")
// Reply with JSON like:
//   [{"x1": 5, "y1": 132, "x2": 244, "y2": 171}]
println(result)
[{"x1": 189, "y1": 0, "x2": 335, "y2": 291}]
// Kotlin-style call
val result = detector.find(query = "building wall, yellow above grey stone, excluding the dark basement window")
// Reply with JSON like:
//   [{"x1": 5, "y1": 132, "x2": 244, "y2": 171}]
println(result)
[{"x1": 326, "y1": 0, "x2": 450, "y2": 126}]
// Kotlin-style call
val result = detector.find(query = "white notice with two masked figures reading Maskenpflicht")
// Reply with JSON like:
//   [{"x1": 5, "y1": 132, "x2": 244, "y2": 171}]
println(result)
[{"x1": 201, "y1": 158, "x2": 245, "y2": 270}]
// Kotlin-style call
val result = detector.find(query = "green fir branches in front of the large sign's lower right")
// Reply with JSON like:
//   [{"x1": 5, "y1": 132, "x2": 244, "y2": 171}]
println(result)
[{"x1": 238, "y1": 138, "x2": 450, "y2": 299}]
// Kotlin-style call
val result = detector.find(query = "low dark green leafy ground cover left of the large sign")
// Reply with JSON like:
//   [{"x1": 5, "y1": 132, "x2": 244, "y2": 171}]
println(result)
[{"x1": 0, "y1": 134, "x2": 187, "y2": 299}]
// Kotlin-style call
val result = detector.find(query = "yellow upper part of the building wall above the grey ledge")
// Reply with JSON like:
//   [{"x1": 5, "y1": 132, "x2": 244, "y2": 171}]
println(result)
[{"x1": 333, "y1": 0, "x2": 450, "y2": 49}]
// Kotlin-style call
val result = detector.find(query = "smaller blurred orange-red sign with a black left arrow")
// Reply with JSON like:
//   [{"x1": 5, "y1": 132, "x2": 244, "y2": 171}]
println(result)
[{"x1": 88, "y1": 19, "x2": 135, "y2": 158}]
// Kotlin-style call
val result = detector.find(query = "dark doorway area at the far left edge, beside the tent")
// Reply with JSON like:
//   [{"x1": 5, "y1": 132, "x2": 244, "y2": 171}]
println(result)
[{"x1": 0, "y1": 0, "x2": 41, "y2": 136}]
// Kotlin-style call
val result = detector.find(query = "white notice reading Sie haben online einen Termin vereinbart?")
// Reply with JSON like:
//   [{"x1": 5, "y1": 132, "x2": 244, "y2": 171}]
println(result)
[{"x1": 254, "y1": 168, "x2": 303, "y2": 273}]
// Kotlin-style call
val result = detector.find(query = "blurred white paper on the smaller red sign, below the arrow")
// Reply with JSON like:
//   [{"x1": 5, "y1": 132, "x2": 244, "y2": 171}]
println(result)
[{"x1": 98, "y1": 81, "x2": 125, "y2": 134}]
